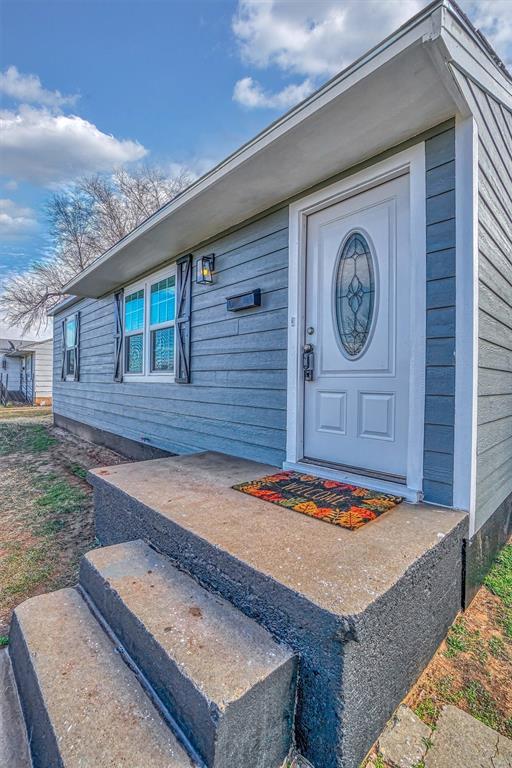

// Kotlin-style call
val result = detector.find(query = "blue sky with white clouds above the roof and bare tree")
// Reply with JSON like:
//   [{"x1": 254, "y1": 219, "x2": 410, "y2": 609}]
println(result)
[{"x1": 0, "y1": 0, "x2": 512, "y2": 334}]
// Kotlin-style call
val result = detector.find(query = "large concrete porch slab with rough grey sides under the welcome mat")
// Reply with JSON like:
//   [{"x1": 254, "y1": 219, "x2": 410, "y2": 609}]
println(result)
[{"x1": 90, "y1": 453, "x2": 467, "y2": 768}]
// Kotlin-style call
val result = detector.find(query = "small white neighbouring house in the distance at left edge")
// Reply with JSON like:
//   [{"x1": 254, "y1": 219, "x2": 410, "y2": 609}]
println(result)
[{"x1": 0, "y1": 339, "x2": 53, "y2": 405}]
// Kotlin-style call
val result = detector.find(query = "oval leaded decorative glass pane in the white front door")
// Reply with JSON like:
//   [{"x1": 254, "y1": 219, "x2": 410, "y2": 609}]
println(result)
[{"x1": 335, "y1": 232, "x2": 375, "y2": 358}]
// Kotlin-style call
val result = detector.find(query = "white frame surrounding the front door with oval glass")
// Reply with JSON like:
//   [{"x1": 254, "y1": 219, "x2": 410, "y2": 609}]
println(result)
[{"x1": 283, "y1": 142, "x2": 426, "y2": 502}]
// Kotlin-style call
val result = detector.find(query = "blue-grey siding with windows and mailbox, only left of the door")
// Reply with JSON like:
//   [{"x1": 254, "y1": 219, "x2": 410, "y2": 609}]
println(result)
[{"x1": 54, "y1": 208, "x2": 288, "y2": 465}]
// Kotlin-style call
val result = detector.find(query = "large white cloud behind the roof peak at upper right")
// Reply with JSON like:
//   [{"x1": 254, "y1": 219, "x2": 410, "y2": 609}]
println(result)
[{"x1": 232, "y1": 0, "x2": 512, "y2": 109}]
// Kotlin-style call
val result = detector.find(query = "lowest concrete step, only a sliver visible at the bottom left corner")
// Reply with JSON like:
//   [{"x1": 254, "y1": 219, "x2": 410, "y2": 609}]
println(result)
[{"x1": 0, "y1": 648, "x2": 32, "y2": 768}]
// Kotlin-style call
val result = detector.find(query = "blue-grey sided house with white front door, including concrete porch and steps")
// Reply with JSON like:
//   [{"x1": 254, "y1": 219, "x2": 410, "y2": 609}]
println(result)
[{"x1": 5, "y1": 0, "x2": 512, "y2": 768}]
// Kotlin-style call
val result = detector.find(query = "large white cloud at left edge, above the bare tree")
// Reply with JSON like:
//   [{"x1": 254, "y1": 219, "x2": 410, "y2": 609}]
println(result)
[{"x1": 0, "y1": 105, "x2": 147, "y2": 184}]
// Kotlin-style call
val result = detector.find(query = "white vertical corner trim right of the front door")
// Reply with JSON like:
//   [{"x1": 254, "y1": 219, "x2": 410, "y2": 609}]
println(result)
[{"x1": 453, "y1": 117, "x2": 478, "y2": 535}]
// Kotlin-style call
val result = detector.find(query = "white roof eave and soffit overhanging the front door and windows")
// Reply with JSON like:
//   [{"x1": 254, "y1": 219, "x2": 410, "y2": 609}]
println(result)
[{"x1": 63, "y1": 0, "x2": 512, "y2": 300}]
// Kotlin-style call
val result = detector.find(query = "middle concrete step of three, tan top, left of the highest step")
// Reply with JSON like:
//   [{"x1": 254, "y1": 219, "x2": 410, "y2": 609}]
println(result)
[{"x1": 9, "y1": 589, "x2": 198, "y2": 768}]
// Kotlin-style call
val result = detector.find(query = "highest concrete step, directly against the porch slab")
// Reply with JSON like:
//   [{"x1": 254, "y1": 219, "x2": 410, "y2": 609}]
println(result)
[{"x1": 80, "y1": 541, "x2": 295, "y2": 768}]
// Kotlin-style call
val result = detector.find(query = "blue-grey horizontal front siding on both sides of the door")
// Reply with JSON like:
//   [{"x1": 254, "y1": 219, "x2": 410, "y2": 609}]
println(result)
[{"x1": 54, "y1": 120, "x2": 455, "y2": 496}]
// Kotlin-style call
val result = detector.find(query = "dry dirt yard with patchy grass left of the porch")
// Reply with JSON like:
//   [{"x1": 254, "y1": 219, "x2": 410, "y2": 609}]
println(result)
[{"x1": 0, "y1": 413, "x2": 126, "y2": 646}]
